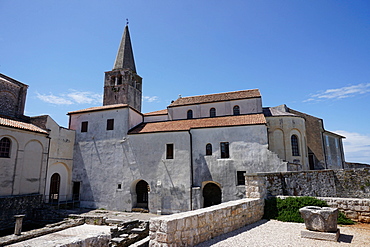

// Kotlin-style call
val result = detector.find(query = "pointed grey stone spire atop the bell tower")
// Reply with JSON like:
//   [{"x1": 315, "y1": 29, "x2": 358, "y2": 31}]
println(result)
[{"x1": 113, "y1": 22, "x2": 136, "y2": 73}]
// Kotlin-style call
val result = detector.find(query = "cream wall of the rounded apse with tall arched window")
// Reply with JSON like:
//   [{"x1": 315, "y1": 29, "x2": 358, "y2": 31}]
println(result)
[{"x1": 266, "y1": 116, "x2": 309, "y2": 170}]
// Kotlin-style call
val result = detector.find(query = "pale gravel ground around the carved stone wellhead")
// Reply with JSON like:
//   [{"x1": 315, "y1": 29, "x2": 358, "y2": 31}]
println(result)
[{"x1": 197, "y1": 220, "x2": 370, "y2": 247}]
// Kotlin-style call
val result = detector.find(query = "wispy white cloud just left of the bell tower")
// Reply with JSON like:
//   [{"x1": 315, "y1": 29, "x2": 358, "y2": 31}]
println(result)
[{"x1": 36, "y1": 89, "x2": 103, "y2": 105}]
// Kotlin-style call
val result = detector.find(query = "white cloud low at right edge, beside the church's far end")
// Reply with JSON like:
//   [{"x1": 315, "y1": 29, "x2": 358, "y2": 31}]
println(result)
[{"x1": 335, "y1": 130, "x2": 370, "y2": 164}]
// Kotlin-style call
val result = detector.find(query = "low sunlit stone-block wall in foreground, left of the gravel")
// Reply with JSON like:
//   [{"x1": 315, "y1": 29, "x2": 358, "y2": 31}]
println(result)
[{"x1": 149, "y1": 198, "x2": 264, "y2": 247}]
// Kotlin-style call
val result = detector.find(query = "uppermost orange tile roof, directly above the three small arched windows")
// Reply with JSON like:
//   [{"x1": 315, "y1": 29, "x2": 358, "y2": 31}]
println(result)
[{"x1": 169, "y1": 89, "x2": 261, "y2": 107}]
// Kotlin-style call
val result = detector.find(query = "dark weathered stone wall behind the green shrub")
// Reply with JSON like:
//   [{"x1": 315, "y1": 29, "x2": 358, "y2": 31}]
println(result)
[{"x1": 246, "y1": 168, "x2": 370, "y2": 198}]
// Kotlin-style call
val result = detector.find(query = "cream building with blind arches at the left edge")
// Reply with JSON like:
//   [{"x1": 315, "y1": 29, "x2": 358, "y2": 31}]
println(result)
[{"x1": 0, "y1": 74, "x2": 75, "y2": 229}]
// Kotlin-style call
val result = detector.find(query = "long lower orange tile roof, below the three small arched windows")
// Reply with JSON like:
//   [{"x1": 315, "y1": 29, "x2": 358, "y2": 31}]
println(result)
[{"x1": 129, "y1": 114, "x2": 266, "y2": 134}]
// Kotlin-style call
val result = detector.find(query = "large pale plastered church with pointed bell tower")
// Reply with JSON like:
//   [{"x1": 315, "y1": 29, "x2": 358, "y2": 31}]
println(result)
[{"x1": 66, "y1": 26, "x2": 344, "y2": 214}]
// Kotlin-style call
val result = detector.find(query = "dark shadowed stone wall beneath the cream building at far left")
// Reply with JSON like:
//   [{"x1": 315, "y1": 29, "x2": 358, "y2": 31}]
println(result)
[{"x1": 0, "y1": 194, "x2": 42, "y2": 230}]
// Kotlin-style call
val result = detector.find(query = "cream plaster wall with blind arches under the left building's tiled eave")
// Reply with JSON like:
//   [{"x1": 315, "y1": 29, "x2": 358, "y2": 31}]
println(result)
[{"x1": 0, "y1": 127, "x2": 49, "y2": 196}]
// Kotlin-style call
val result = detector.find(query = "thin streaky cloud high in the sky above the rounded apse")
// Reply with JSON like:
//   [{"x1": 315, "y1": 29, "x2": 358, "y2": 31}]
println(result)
[{"x1": 304, "y1": 83, "x2": 370, "y2": 102}]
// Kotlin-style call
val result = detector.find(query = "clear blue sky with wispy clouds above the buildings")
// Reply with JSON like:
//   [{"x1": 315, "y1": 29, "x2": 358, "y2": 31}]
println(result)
[{"x1": 0, "y1": 0, "x2": 370, "y2": 163}]
